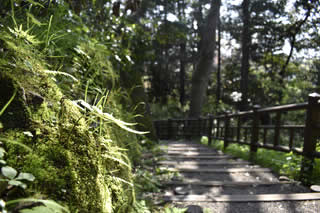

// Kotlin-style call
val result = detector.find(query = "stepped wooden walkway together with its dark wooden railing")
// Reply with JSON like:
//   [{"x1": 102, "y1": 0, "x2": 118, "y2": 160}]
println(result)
[{"x1": 154, "y1": 94, "x2": 320, "y2": 212}]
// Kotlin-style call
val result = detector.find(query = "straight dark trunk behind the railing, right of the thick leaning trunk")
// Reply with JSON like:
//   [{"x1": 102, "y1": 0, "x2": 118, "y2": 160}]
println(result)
[{"x1": 239, "y1": 0, "x2": 251, "y2": 110}]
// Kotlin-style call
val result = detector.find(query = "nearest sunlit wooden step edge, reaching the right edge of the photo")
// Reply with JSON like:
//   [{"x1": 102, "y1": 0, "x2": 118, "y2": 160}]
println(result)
[{"x1": 163, "y1": 193, "x2": 320, "y2": 202}]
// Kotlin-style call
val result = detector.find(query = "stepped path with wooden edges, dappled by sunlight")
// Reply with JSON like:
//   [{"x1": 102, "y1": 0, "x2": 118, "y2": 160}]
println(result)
[{"x1": 158, "y1": 141, "x2": 320, "y2": 213}]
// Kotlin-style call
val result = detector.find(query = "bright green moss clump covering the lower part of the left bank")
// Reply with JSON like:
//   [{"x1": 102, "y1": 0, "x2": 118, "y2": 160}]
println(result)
[{"x1": 1, "y1": 74, "x2": 140, "y2": 213}]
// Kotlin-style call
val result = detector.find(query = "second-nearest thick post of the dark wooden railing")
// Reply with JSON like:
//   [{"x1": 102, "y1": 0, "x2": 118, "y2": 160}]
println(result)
[{"x1": 250, "y1": 105, "x2": 260, "y2": 159}]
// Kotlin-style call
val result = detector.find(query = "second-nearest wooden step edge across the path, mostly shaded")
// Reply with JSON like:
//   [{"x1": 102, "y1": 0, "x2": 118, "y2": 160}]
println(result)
[{"x1": 163, "y1": 181, "x2": 297, "y2": 187}]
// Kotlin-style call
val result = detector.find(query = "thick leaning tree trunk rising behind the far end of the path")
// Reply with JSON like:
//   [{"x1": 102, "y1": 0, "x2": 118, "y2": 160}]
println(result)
[{"x1": 189, "y1": 0, "x2": 221, "y2": 117}]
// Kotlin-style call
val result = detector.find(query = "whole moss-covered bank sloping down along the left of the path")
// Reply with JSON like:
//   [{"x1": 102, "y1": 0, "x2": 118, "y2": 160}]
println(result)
[{"x1": 0, "y1": 22, "x2": 145, "y2": 213}]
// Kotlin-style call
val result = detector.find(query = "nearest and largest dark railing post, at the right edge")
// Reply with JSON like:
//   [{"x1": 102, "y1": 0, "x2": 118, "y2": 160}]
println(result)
[{"x1": 300, "y1": 93, "x2": 320, "y2": 183}]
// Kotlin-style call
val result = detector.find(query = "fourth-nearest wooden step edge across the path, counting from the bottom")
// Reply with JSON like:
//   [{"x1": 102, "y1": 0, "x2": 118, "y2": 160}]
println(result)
[{"x1": 158, "y1": 161, "x2": 251, "y2": 166}]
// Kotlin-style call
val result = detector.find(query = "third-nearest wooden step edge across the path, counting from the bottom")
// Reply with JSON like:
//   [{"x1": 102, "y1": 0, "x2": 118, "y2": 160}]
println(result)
[{"x1": 160, "y1": 167, "x2": 272, "y2": 173}]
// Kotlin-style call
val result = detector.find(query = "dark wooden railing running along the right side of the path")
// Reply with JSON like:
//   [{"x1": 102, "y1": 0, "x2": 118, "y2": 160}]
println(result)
[{"x1": 154, "y1": 93, "x2": 320, "y2": 181}]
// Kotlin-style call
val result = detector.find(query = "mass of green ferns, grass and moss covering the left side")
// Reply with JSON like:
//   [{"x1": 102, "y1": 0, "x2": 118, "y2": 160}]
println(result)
[{"x1": 0, "y1": 1, "x2": 155, "y2": 212}]
